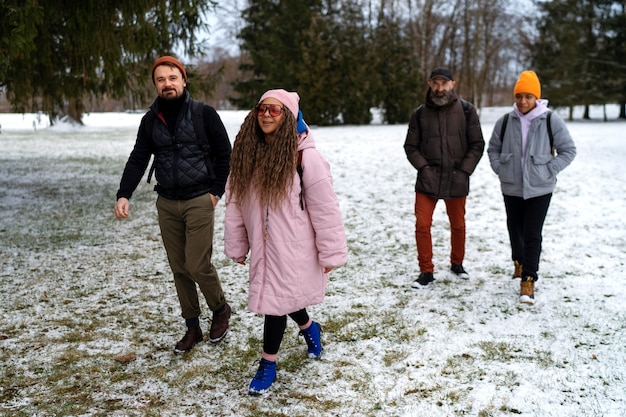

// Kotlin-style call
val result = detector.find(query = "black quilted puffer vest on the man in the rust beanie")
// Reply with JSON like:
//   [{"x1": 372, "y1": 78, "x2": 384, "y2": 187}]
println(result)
[{"x1": 151, "y1": 95, "x2": 211, "y2": 200}]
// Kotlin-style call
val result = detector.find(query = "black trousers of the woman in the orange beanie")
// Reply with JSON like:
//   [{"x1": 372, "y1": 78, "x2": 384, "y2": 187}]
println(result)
[{"x1": 504, "y1": 194, "x2": 552, "y2": 281}]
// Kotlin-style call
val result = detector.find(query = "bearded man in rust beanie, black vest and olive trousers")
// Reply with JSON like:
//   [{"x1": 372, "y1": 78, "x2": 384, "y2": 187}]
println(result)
[{"x1": 115, "y1": 56, "x2": 231, "y2": 353}]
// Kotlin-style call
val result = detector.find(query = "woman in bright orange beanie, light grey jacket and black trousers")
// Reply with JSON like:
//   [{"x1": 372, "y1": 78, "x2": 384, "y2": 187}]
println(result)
[{"x1": 487, "y1": 71, "x2": 576, "y2": 304}]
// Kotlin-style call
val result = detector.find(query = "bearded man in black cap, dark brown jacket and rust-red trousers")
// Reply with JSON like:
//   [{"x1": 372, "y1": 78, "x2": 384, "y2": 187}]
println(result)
[{"x1": 404, "y1": 68, "x2": 485, "y2": 288}]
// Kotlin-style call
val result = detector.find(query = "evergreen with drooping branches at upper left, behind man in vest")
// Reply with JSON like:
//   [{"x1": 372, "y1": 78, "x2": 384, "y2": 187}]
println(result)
[{"x1": 0, "y1": 0, "x2": 215, "y2": 121}]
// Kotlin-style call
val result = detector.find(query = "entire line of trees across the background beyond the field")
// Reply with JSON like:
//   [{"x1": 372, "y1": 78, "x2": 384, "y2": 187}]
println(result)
[{"x1": 0, "y1": 0, "x2": 626, "y2": 125}]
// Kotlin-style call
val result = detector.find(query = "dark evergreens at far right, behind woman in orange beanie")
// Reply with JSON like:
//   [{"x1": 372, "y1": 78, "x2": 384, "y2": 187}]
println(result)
[{"x1": 529, "y1": 0, "x2": 626, "y2": 119}]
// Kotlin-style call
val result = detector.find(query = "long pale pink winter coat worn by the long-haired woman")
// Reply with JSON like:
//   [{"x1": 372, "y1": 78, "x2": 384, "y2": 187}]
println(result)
[{"x1": 224, "y1": 131, "x2": 348, "y2": 316}]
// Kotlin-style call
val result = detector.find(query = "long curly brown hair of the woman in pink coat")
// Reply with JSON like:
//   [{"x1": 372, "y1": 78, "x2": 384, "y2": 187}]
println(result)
[{"x1": 228, "y1": 109, "x2": 298, "y2": 208}]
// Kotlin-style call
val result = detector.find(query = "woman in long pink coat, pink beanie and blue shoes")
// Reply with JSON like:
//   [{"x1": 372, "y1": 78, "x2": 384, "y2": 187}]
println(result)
[{"x1": 224, "y1": 90, "x2": 348, "y2": 395}]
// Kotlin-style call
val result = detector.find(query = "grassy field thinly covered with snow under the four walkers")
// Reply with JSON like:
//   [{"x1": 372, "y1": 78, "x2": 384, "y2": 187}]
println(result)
[{"x1": 0, "y1": 104, "x2": 626, "y2": 417}]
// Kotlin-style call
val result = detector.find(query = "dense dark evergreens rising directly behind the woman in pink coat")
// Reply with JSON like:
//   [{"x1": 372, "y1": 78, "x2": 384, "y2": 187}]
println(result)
[{"x1": 233, "y1": 0, "x2": 375, "y2": 125}]
